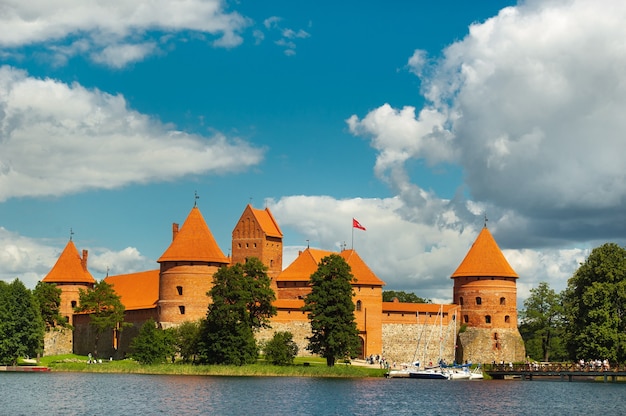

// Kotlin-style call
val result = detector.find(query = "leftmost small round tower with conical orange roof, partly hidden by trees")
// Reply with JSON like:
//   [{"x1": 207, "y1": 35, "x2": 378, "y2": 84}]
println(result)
[{"x1": 42, "y1": 239, "x2": 96, "y2": 325}]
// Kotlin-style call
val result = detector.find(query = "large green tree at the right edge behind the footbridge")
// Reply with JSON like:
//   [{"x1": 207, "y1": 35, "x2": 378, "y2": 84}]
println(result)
[{"x1": 564, "y1": 243, "x2": 626, "y2": 363}]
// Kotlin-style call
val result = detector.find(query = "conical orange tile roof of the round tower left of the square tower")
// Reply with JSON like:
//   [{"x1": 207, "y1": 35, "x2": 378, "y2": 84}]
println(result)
[{"x1": 157, "y1": 207, "x2": 230, "y2": 264}]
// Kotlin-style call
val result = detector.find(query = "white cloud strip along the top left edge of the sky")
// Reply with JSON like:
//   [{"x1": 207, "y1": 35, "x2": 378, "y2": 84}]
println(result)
[{"x1": 0, "y1": 0, "x2": 251, "y2": 67}]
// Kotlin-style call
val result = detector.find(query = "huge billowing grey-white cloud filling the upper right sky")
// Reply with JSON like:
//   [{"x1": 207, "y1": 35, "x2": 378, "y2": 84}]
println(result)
[{"x1": 347, "y1": 0, "x2": 626, "y2": 248}]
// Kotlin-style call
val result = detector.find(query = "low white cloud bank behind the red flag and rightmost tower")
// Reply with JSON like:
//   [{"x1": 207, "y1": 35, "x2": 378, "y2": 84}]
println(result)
[{"x1": 266, "y1": 195, "x2": 588, "y2": 308}]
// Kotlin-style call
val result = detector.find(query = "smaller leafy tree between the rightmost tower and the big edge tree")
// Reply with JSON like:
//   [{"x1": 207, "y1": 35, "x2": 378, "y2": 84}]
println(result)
[{"x1": 520, "y1": 282, "x2": 567, "y2": 361}]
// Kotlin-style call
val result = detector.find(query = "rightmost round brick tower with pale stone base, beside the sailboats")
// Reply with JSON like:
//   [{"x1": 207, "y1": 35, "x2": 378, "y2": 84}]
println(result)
[{"x1": 451, "y1": 226, "x2": 526, "y2": 363}]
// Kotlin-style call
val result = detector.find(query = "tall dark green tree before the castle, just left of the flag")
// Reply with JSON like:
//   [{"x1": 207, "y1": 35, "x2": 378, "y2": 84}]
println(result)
[{"x1": 303, "y1": 254, "x2": 361, "y2": 367}]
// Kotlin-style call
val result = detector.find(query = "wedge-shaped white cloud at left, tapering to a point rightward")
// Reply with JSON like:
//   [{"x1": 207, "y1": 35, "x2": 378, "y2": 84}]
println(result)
[{"x1": 0, "y1": 66, "x2": 264, "y2": 201}]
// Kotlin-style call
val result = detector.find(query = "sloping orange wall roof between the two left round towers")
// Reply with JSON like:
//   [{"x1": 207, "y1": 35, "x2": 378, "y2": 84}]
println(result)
[{"x1": 104, "y1": 269, "x2": 159, "y2": 310}]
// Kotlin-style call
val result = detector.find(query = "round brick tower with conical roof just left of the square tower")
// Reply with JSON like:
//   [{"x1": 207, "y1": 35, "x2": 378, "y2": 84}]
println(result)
[{"x1": 157, "y1": 206, "x2": 230, "y2": 328}]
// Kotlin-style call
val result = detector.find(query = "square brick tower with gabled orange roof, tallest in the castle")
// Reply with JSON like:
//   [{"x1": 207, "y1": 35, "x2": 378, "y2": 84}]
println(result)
[{"x1": 232, "y1": 204, "x2": 283, "y2": 291}]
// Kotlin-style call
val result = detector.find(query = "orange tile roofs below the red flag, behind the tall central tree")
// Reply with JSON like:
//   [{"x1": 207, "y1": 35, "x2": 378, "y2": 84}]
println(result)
[{"x1": 276, "y1": 248, "x2": 385, "y2": 286}]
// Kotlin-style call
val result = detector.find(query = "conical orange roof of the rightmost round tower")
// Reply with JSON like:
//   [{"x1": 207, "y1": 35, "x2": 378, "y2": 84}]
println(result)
[{"x1": 451, "y1": 227, "x2": 519, "y2": 278}]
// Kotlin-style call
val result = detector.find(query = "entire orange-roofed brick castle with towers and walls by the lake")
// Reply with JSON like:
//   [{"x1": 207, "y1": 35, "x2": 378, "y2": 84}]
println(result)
[{"x1": 43, "y1": 205, "x2": 525, "y2": 363}]
